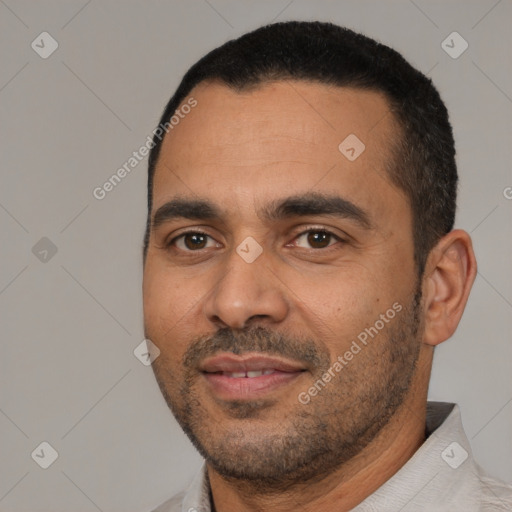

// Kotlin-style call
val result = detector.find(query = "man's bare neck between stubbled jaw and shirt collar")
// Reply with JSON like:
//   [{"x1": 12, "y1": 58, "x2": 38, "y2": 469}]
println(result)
[{"x1": 207, "y1": 348, "x2": 430, "y2": 512}]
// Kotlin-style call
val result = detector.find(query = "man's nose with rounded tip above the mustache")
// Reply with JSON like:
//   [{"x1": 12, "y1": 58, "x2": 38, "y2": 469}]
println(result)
[{"x1": 204, "y1": 246, "x2": 289, "y2": 329}]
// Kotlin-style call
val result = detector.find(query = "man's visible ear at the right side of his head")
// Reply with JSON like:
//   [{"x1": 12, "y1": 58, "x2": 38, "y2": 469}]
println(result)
[{"x1": 423, "y1": 229, "x2": 476, "y2": 345}]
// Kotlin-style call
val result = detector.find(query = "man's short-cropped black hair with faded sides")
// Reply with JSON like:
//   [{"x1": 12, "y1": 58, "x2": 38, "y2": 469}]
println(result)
[{"x1": 144, "y1": 21, "x2": 458, "y2": 276}]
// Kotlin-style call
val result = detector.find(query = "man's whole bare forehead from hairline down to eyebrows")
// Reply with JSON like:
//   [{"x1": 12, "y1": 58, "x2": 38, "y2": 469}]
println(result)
[{"x1": 153, "y1": 81, "x2": 400, "y2": 222}]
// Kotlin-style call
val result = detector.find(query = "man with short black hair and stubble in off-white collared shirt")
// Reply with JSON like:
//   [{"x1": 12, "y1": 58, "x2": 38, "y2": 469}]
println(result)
[{"x1": 143, "y1": 22, "x2": 512, "y2": 512}]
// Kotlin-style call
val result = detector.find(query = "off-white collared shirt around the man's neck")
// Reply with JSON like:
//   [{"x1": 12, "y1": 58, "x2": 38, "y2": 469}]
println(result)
[{"x1": 153, "y1": 402, "x2": 512, "y2": 512}]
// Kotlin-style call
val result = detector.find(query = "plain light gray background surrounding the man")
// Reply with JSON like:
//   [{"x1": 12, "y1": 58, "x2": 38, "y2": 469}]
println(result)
[{"x1": 0, "y1": 0, "x2": 512, "y2": 512}]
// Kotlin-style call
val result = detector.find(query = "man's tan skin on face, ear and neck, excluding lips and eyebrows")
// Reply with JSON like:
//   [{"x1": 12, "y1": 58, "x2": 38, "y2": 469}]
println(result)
[{"x1": 143, "y1": 81, "x2": 476, "y2": 512}]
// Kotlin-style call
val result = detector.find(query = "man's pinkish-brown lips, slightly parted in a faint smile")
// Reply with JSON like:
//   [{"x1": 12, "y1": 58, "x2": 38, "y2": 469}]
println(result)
[{"x1": 199, "y1": 354, "x2": 307, "y2": 400}]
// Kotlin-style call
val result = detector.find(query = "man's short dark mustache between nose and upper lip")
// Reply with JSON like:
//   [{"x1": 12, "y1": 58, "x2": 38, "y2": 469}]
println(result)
[{"x1": 183, "y1": 326, "x2": 330, "y2": 370}]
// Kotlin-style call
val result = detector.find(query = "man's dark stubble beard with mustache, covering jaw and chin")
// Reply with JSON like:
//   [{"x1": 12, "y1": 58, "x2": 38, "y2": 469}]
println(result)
[{"x1": 153, "y1": 289, "x2": 422, "y2": 492}]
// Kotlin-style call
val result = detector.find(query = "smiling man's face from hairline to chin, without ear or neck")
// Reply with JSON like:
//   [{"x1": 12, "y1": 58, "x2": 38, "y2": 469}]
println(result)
[{"x1": 144, "y1": 81, "x2": 421, "y2": 484}]
